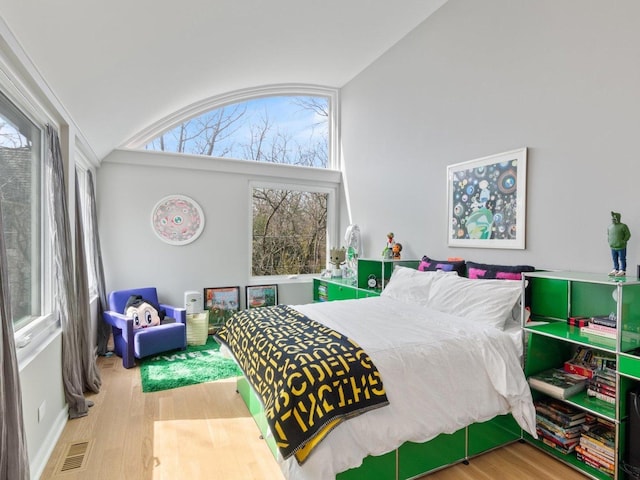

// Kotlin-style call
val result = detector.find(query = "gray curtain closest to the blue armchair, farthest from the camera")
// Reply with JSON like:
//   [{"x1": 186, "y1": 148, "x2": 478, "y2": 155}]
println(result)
[{"x1": 87, "y1": 172, "x2": 111, "y2": 355}]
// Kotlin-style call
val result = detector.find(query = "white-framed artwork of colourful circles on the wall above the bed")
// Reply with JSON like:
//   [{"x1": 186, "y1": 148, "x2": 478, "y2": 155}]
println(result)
[{"x1": 447, "y1": 147, "x2": 527, "y2": 249}]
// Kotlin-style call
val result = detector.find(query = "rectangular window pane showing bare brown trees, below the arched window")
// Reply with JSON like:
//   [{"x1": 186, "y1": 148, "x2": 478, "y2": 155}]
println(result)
[{"x1": 252, "y1": 186, "x2": 331, "y2": 276}]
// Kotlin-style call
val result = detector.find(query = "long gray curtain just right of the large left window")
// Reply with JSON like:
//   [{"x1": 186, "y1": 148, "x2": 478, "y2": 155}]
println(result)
[{"x1": 45, "y1": 125, "x2": 93, "y2": 418}]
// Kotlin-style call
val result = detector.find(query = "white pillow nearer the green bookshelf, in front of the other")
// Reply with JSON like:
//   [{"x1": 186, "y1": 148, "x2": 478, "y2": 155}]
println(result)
[{"x1": 429, "y1": 275, "x2": 522, "y2": 330}]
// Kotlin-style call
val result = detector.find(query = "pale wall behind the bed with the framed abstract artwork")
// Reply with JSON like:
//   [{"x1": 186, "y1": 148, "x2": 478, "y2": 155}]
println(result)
[{"x1": 341, "y1": 0, "x2": 640, "y2": 275}]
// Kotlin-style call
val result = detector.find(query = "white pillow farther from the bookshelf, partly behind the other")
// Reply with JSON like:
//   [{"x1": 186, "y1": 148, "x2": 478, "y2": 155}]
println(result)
[{"x1": 380, "y1": 265, "x2": 456, "y2": 305}]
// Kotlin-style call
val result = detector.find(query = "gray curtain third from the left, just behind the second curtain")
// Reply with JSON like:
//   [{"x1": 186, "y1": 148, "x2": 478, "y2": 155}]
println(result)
[{"x1": 75, "y1": 172, "x2": 102, "y2": 393}]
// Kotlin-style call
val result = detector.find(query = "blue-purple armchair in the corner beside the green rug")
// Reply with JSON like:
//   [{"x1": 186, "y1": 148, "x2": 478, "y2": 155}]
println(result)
[{"x1": 103, "y1": 287, "x2": 187, "y2": 368}]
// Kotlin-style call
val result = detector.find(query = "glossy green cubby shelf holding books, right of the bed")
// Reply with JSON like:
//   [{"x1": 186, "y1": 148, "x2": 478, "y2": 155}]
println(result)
[{"x1": 523, "y1": 271, "x2": 640, "y2": 480}]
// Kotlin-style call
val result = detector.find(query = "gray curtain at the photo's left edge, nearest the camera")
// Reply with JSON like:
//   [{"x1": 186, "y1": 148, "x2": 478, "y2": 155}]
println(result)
[{"x1": 0, "y1": 192, "x2": 30, "y2": 480}]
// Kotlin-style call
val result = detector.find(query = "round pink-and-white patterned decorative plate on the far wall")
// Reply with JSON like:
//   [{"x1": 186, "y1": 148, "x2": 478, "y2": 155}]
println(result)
[{"x1": 151, "y1": 195, "x2": 204, "y2": 245}]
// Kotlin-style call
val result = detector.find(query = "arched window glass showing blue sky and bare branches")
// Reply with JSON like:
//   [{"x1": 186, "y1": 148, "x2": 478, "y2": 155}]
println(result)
[{"x1": 144, "y1": 93, "x2": 333, "y2": 168}]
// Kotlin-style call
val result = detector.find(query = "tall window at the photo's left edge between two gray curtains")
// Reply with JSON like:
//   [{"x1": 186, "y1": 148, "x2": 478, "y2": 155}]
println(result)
[{"x1": 0, "y1": 90, "x2": 42, "y2": 330}]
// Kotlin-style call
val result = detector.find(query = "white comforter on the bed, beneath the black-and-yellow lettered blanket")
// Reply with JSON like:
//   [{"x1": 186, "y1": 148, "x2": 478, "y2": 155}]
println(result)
[{"x1": 280, "y1": 297, "x2": 535, "y2": 480}]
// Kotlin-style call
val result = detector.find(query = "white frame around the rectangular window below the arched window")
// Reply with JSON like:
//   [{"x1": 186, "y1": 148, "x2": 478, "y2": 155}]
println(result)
[{"x1": 247, "y1": 178, "x2": 339, "y2": 283}]
